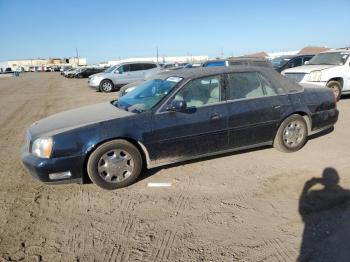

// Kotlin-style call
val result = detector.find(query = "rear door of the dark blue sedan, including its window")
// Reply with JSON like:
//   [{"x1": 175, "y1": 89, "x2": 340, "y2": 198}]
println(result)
[{"x1": 227, "y1": 72, "x2": 290, "y2": 148}]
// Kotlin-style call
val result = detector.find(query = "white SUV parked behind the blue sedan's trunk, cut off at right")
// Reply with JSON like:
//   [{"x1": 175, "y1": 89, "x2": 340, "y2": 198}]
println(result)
[{"x1": 282, "y1": 48, "x2": 350, "y2": 100}]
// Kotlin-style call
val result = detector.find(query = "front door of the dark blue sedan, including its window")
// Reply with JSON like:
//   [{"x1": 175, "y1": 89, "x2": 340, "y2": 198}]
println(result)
[{"x1": 148, "y1": 76, "x2": 228, "y2": 163}]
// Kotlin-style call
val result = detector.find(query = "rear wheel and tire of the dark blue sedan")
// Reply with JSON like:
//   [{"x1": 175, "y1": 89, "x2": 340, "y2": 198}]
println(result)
[{"x1": 273, "y1": 114, "x2": 308, "y2": 153}]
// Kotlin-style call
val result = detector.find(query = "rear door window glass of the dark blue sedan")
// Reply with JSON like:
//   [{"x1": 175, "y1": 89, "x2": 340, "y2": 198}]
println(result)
[{"x1": 228, "y1": 72, "x2": 276, "y2": 100}]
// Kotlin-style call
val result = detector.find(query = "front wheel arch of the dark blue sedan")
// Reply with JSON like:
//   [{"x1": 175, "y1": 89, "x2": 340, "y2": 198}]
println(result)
[{"x1": 82, "y1": 137, "x2": 150, "y2": 183}]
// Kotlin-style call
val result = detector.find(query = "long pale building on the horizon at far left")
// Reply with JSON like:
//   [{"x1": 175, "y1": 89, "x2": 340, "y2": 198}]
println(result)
[{"x1": 7, "y1": 57, "x2": 87, "y2": 71}]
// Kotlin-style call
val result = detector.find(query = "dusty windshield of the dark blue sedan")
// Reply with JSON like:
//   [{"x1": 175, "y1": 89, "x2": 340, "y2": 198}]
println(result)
[{"x1": 113, "y1": 77, "x2": 182, "y2": 113}]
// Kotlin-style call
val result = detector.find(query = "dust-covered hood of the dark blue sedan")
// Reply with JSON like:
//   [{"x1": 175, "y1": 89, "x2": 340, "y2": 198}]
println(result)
[{"x1": 29, "y1": 102, "x2": 134, "y2": 138}]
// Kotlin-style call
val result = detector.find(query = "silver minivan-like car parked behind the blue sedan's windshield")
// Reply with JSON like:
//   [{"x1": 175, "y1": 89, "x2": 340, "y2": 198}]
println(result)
[{"x1": 88, "y1": 62, "x2": 161, "y2": 92}]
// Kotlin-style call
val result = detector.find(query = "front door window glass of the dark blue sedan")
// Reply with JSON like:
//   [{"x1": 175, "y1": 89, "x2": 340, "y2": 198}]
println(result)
[{"x1": 174, "y1": 76, "x2": 221, "y2": 107}]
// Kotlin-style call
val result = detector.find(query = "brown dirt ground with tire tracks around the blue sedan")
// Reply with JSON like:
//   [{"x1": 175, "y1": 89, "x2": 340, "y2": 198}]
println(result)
[{"x1": 0, "y1": 73, "x2": 350, "y2": 262}]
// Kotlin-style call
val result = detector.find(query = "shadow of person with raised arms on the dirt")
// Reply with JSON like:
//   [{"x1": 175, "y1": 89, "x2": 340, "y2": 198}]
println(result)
[{"x1": 298, "y1": 167, "x2": 350, "y2": 262}]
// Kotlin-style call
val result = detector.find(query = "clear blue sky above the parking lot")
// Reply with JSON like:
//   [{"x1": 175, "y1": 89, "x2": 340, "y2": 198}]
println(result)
[{"x1": 0, "y1": 0, "x2": 350, "y2": 63}]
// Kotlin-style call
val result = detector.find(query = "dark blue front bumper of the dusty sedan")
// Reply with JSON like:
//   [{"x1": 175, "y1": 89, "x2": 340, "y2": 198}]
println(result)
[{"x1": 22, "y1": 147, "x2": 85, "y2": 184}]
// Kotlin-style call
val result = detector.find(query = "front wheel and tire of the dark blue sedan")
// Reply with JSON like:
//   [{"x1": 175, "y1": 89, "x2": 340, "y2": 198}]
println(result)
[{"x1": 87, "y1": 139, "x2": 142, "y2": 190}]
